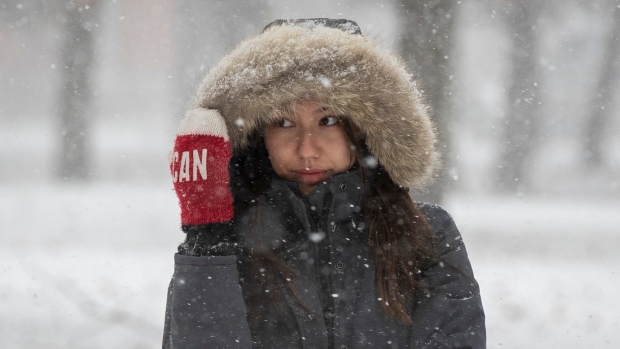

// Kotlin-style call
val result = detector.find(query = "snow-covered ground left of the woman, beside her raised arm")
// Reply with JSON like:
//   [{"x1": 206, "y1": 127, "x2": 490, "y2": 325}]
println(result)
[{"x1": 0, "y1": 184, "x2": 182, "y2": 348}]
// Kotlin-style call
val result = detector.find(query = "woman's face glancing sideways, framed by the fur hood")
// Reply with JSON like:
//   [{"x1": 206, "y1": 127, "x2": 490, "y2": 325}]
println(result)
[{"x1": 264, "y1": 102, "x2": 355, "y2": 195}]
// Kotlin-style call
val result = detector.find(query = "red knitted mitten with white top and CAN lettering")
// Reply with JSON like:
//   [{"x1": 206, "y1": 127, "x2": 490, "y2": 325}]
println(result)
[{"x1": 170, "y1": 108, "x2": 233, "y2": 225}]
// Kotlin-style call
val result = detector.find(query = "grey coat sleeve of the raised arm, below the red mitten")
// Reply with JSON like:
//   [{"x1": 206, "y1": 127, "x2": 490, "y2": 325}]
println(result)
[{"x1": 162, "y1": 254, "x2": 252, "y2": 349}]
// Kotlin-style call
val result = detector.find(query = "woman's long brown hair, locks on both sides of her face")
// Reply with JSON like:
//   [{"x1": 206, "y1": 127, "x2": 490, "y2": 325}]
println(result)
[{"x1": 231, "y1": 119, "x2": 437, "y2": 324}]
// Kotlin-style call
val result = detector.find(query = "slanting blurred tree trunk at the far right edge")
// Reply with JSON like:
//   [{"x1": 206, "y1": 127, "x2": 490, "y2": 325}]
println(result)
[{"x1": 584, "y1": 0, "x2": 620, "y2": 167}]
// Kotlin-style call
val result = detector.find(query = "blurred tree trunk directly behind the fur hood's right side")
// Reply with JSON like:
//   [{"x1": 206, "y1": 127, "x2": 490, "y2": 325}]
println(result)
[{"x1": 397, "y1": 0, "x2": 459, "y2": 203}]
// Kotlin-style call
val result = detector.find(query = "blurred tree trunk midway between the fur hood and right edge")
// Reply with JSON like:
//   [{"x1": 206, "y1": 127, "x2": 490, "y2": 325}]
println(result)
[{"x1": 497, "y1": 0, "x2": 546, "y2": 192}]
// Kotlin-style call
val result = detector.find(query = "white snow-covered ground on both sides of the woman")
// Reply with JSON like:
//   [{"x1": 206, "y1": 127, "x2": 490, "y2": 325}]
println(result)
[{"x1": 0, "y1": 181, "x2": 620, "y2": 348}]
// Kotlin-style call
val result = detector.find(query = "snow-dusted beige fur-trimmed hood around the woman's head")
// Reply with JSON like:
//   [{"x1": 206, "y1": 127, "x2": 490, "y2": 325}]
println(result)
[{"x1": 193, "y1": 20, "x2": 438, "y2": 189}]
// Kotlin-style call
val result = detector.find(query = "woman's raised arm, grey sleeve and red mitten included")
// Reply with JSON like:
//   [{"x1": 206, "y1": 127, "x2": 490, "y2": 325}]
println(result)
[{"x1": 162, "y1": 109, "x2": 252, "y2": 348}]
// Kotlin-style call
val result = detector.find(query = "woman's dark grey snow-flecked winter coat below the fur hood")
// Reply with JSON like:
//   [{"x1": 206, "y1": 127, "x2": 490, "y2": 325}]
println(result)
[{"x1": 164, "y1": 171, "x2": 485, "y2": 348}]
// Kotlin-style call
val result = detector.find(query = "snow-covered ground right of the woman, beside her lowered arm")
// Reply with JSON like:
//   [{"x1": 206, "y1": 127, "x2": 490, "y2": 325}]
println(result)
[{"x1": 446, "y1": 197, "x2": 620, "y2": 348}]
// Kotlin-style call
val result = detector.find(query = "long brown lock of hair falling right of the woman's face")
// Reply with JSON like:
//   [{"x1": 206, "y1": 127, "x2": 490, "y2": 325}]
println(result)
[{"x1": 343, "y1": 121, "x2": 438, "y2": 325}]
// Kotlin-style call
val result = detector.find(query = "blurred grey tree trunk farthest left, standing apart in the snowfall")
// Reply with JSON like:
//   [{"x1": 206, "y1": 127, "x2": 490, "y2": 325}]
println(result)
[{"x1": 57, "y1": 0, "x2": 99, "y2": 181}]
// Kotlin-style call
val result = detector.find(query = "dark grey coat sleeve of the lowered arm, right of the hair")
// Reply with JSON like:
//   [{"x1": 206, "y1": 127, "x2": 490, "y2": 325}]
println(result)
[{"x1": 411, "y1": 205, "x2": 486, "y2": 349}]
